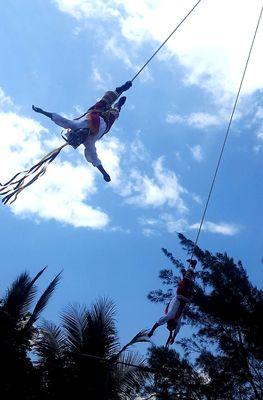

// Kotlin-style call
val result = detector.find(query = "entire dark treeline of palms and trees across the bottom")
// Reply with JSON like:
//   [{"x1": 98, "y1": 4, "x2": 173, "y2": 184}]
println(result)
[{"x1": 0, "y1": 234, "x2": 263, "y2": 400}]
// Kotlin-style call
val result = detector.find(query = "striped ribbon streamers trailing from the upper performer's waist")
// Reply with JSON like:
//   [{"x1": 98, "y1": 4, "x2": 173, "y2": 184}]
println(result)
[{"x1": 0, "y1": 143, "x2": 68, "y2": 204}]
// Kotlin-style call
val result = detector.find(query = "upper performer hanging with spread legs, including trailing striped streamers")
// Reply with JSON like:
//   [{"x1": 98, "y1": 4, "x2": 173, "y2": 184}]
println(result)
[{"x1": 0, "y1": 81, "x2": 132, "y2": 204}]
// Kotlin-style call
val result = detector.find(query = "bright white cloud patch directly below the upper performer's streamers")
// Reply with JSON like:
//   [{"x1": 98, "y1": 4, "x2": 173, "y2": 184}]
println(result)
[{"x1": 12, "y1": 161, "x2": 110, "y2": 229}]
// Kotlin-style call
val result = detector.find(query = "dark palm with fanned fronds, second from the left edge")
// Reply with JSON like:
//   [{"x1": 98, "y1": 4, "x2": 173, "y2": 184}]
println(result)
[{"x1": 37, "y1": 298, "x2": 151, "y2": 400}]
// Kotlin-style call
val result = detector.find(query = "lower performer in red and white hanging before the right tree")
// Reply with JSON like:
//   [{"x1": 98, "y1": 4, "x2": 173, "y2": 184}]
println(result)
[{"x1": 148, "y1": 260, "x2": 197, "y2": 347}]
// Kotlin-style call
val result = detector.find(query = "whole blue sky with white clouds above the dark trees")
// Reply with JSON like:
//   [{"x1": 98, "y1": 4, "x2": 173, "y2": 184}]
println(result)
[{"x1": 0, "y1": 0, "x2": 263, "y2": 344}]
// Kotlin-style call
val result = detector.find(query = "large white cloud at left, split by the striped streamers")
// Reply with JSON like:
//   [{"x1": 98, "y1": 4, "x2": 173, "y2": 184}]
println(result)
[{"x1": 0, "y1": 91, "x2": 110, "y2": 229}]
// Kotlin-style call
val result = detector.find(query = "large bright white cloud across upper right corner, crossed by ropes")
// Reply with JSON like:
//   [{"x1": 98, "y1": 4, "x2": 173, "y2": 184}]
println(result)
[{"x1": 55, "y1": 0, "x2": 263, "y2": 101}]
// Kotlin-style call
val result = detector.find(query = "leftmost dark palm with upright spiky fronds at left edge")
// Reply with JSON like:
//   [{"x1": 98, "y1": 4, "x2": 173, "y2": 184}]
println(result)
[{"x1": 0, "y1": 268, "x2": 60, "y2": 399}]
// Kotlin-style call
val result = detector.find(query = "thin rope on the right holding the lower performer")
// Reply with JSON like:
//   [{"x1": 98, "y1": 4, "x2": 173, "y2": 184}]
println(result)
[{"x1": 191, "y1": 4, "x2": 263, "y2": 260}]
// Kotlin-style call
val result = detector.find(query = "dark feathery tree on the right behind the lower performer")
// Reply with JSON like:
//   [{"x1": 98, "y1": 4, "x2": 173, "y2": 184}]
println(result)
[{"x1": 148, "y1": 234, "x2": 263, "y2": 400}]
